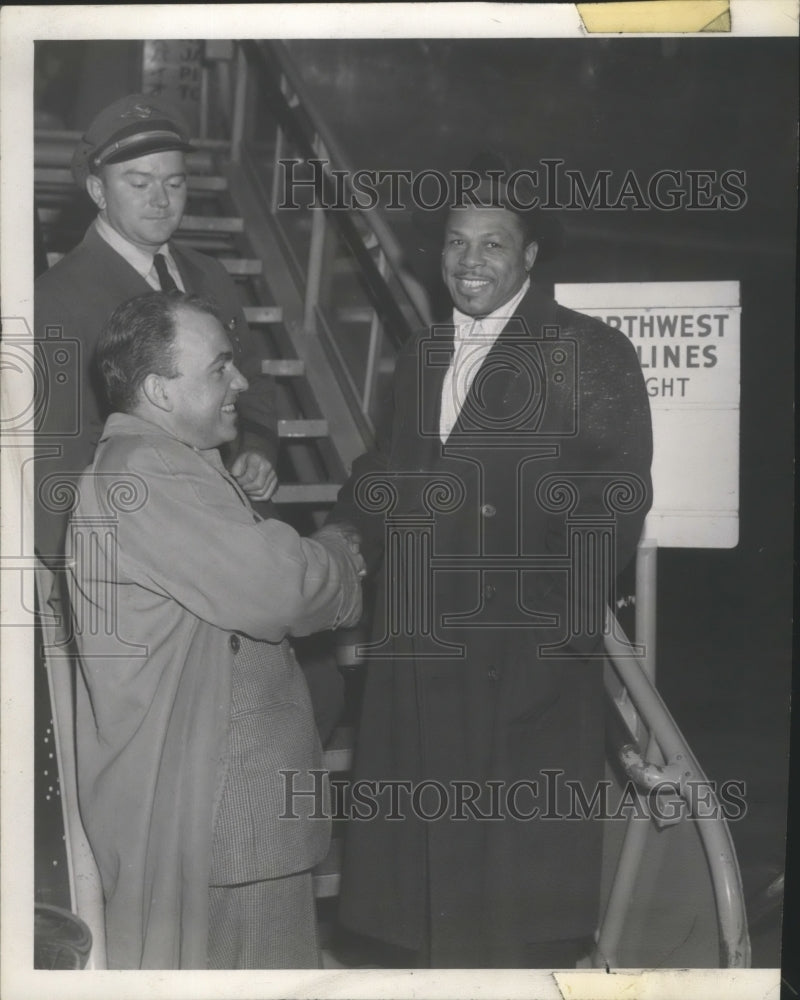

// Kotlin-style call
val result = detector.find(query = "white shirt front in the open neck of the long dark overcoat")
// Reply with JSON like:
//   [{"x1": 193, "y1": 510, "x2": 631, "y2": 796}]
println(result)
[{"x1": 439, "y1": 278, "x2": 531, "y2": 444}]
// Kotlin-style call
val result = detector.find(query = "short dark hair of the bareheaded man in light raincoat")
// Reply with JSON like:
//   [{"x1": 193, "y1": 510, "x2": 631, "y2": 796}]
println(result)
[{"x1": 95, "y1": 292, "x2": 219, "y2": 413}]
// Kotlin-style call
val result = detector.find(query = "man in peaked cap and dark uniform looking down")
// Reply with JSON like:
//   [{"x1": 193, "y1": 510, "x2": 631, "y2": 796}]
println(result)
[{"x1": 34, "y1": 94, "x2": 277, "y2": 565}]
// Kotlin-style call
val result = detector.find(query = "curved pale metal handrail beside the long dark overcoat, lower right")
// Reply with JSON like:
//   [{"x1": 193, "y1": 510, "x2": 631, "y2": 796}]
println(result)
[{"x1": 605, "y1": 610, "x2": 750, "y2": 968}]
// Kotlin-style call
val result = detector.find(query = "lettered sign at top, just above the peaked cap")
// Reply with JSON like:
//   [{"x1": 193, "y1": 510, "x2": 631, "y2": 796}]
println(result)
[{"x1": 142, "y1": 39, "x2": 203, "y2": 135}]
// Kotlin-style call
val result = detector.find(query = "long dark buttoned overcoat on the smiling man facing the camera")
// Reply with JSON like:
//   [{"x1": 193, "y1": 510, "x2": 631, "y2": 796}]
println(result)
[{"x1": 332, "y1": 280, "x2": 652, "y2": 967}]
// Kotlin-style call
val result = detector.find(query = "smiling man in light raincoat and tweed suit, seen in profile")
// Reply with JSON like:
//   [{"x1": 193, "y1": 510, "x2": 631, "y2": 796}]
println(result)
[{"x1": 67, "y1": 292, "x2": 363, "y2": 969}]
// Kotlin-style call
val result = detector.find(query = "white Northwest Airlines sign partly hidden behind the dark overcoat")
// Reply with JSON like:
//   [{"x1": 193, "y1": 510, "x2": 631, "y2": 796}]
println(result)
[{"x1": 555, "y1": 281, "x2": 741, "y2": 548}]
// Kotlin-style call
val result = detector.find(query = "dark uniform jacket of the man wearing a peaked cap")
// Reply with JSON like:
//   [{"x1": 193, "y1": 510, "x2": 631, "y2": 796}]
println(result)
[{"x1": 34, "y1": 224, "x2": 277, "y2": 560}]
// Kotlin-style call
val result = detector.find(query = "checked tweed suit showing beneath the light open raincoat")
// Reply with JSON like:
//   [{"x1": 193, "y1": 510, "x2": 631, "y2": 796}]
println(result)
[{"x1": 208, "y1": 635, "x2": 330, "y2": 969}]
